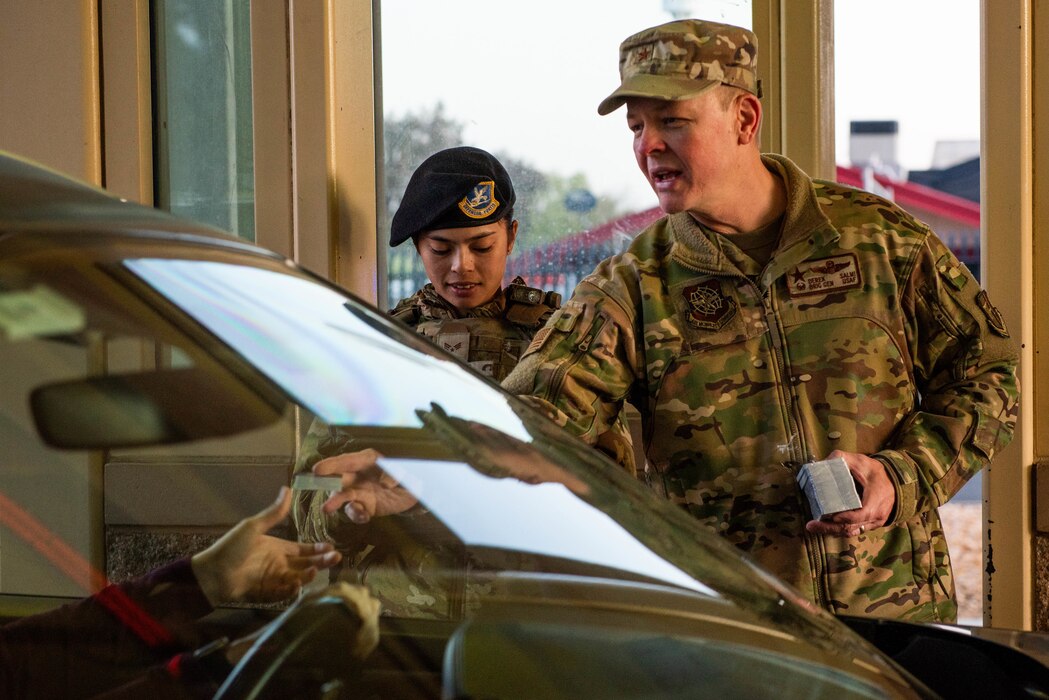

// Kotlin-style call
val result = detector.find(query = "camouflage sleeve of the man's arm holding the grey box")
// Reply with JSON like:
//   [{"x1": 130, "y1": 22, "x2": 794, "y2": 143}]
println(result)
[{"x1": 874, "y1": 233, "x2": 1020, "y2": 522}]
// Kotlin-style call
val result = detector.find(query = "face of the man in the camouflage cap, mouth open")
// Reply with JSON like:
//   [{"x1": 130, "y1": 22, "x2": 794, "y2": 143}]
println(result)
[{"x1": 626, "y1": 89, "x2": 738, "y2": 219}]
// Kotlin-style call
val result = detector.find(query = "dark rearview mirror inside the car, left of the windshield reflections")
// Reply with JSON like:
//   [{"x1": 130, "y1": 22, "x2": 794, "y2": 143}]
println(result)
[{"x1": 29, "y1": 367, "x2": 280, "y2": 449}]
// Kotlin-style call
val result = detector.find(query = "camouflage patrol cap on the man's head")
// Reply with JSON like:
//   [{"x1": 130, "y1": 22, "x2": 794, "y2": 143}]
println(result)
[{"x1": 597, "y1": 20, "x2": 762, "y2": 114}]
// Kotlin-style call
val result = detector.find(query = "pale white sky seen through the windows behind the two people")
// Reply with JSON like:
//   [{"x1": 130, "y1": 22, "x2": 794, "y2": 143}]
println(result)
[{"x1": 381, "y1": 0, "x2": 980, "y2": 208}]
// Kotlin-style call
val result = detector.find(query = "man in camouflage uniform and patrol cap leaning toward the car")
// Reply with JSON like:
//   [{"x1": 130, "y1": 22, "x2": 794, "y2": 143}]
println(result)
[{"x1": 504, "y1": 20, "x2": 1019, "y2": 621}]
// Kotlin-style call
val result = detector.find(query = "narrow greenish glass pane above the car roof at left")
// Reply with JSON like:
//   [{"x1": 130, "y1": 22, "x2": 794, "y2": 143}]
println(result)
[{"x1": 153, "y1": 0, "x2": 255, "y2": 240}]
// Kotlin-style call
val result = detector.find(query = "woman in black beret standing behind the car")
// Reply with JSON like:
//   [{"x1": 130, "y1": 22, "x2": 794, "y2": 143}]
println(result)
[{"x1": 390, "y1": 146, "x2": 560, "y2": 381}]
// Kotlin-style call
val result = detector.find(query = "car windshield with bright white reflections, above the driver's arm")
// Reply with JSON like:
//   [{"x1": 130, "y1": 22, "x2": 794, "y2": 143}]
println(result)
[{"x1": 0, "y1": 241, "x2": 910, "y2": 697}]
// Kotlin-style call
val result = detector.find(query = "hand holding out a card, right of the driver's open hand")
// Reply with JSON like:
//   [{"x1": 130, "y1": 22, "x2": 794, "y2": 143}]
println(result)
[{"x1": 314, "y1": 448, "x2": 419, "y2": 525}]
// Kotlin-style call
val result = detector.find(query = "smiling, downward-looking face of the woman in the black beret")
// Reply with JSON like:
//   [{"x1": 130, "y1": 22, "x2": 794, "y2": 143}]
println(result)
[{"x1": 414, "y1": 219, "x2": 517, "y2": 311}]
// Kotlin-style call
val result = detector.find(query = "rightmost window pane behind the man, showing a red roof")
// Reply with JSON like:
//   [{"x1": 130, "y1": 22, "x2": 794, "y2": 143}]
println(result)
[{"x1": 834, "y1": 0, "x2": 983, "y2": 624}]
